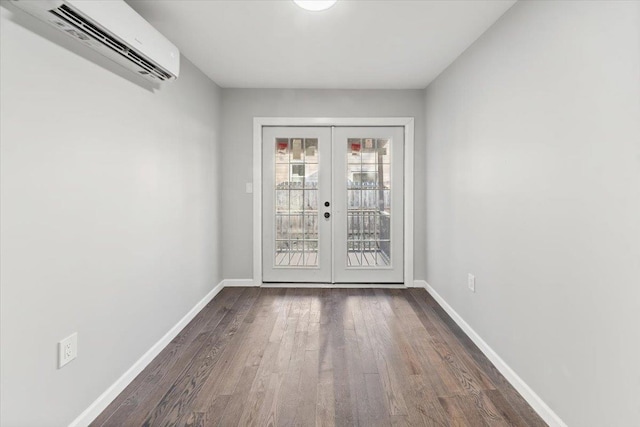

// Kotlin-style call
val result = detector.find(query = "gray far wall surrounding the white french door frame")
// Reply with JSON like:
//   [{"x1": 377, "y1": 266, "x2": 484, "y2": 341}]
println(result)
[{"x1": 222, "y1": 89, "x2": 425, "y2": 279}]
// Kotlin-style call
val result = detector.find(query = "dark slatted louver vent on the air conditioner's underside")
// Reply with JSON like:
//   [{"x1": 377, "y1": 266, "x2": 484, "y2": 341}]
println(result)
[{"x1": 50, "y1": 4, "x2": 171, "y2": 81}]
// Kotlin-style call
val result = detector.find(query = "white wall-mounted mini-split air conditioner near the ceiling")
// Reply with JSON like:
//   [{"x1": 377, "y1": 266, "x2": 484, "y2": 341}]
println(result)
[{"x1": 12, "y1": 0, "x2": 180, "y2": 83}]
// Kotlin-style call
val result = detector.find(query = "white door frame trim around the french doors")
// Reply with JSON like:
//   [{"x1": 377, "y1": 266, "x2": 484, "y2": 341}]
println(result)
[{"x1": 253, "y1": 117, "x2": 414, "y2": 287}]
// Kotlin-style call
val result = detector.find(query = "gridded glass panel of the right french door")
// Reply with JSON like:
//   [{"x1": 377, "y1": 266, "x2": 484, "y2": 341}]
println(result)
[{"x1": 346, "y1": 138, "x2": 391, "y2": 267}]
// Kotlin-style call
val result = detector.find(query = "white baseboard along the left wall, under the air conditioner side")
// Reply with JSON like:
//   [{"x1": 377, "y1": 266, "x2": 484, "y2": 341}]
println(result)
[{"x1": 69, "y1": 280, "x2": 224, "y2": 427}]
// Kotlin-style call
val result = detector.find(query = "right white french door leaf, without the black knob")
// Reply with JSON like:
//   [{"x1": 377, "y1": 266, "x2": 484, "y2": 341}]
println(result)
[{"x1": 332, "y1": 127, "x2": 404, "y2": 283}]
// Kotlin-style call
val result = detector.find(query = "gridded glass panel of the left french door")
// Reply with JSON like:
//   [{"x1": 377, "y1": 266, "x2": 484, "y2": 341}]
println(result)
[{"x1": 273, "y1": 138, "x2": 319, "y2": 268}]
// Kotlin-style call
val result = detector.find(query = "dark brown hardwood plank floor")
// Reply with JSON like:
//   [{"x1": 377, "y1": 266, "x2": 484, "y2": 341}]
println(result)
[{"x1": 92, "y1": 288, "x2": 546, "y2": 427}]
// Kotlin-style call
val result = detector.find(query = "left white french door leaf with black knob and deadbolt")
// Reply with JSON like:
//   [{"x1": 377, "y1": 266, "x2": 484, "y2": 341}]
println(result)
[{"x1": 262, "y1": 127, "x2": 332, "y2": 283}]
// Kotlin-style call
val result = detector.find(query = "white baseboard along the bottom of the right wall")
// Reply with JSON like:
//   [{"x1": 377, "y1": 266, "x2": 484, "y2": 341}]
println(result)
[{"x1": 424, "y1": 280, "x2": 567, "y2": 427}]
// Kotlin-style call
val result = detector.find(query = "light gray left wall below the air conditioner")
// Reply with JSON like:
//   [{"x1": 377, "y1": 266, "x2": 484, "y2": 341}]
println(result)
[{"x1": 0, "y1": 8, "x2": 222, "y2": 427}]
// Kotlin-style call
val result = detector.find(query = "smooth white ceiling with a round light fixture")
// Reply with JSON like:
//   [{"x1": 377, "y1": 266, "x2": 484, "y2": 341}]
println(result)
[{"x1": 128, "y1": 0, "x2": 515, "y2": 89}]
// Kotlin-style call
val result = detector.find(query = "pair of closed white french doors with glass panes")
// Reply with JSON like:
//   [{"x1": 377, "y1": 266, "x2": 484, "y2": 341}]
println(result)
[{"x1": 262, "y1": 126, "x2": 404, "y2": 283}]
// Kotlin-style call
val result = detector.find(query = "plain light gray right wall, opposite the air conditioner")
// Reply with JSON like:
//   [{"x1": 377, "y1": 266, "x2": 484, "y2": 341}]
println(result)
[{"x1": 426, "y1": 1, "x2": 640, "y2": 427}]
